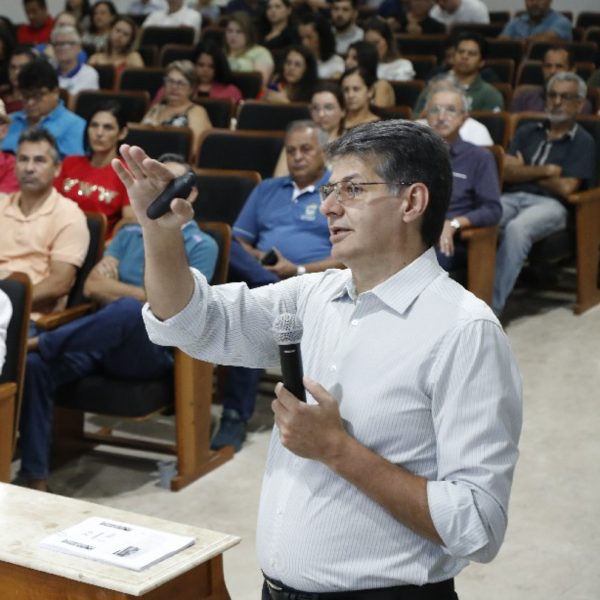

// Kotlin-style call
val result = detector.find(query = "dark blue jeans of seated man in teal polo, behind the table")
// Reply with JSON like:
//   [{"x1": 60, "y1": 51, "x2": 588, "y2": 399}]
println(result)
[{"x1": 20, "y1": 298, "x2": 173, "y2": 479}]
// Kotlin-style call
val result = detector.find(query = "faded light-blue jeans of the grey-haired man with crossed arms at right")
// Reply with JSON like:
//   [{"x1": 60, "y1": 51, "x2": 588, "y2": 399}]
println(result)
[{"x1": 492, "y1": 192, "x2": 567, "y2": 314}]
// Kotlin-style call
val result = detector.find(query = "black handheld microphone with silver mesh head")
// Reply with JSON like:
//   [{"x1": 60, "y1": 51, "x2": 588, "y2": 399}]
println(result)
[{"x1": 272, "y1": 313, "x2": 306, "y2": 402}]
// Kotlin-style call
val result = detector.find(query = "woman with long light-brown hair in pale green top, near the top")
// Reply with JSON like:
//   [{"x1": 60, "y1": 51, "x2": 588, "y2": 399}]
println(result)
[{"x1": 224, "y1": 12, "x2": 274, "y2": 89}]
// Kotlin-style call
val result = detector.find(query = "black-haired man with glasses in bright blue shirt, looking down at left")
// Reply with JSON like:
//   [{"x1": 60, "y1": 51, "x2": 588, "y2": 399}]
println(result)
[{"x1": 2, "y1": 58, "x2": 86, "y2": 160}]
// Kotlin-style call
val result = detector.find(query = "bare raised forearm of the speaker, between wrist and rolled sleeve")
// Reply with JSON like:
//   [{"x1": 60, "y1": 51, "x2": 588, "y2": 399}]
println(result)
[{"x1": 144, "y1": 226, "x2": 194, "y2": 320}]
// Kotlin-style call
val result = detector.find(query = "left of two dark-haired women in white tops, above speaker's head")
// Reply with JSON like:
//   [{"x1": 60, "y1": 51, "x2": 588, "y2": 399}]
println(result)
[{"x1": 298, "y1": 13, "x2": 345, "y2": 79}]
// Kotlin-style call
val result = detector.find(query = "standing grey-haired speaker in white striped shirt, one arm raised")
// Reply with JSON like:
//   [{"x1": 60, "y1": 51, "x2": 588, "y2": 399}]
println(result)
[{"x1": 113, "y1": 120, "x2": 521, "y2": 600}]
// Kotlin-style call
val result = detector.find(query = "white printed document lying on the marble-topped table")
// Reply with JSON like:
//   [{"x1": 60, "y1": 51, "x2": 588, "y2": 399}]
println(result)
[{"x1": 40, "y1": 517, "x2": 195, "y2": 571}]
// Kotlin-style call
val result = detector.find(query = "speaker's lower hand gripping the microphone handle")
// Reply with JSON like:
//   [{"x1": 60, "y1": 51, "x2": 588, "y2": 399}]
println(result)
[{"x1": 271, "y1": 377, "x2": 348, "y2": 464}]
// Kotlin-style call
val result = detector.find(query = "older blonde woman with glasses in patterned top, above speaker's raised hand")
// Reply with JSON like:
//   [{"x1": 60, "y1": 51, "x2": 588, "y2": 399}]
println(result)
[{"x1": 142, "y1": 60, "x2": 212, "y2": 148}]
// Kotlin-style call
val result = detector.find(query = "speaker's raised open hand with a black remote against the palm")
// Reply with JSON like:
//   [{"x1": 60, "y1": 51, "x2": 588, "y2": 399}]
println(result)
[{"x1": 112, "y1": 144, "x2": 198, "y2": 229}]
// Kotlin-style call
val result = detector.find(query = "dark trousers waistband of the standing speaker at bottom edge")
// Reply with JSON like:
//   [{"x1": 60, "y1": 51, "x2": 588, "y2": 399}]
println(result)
[{"x1": 262, "y1": 579, "x2": 458, "y2": 600}]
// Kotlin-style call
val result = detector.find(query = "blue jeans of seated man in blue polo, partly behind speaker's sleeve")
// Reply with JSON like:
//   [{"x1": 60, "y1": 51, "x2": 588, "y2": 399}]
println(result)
[{"x1": 223, "y1": 238, "x2": 279, "y2": 421}]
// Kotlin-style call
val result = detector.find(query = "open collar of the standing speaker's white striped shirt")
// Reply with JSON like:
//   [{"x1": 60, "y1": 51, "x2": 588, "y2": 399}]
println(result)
[{"x1": 332, "y1": 248, "x2": 445, "y2": 314}]
